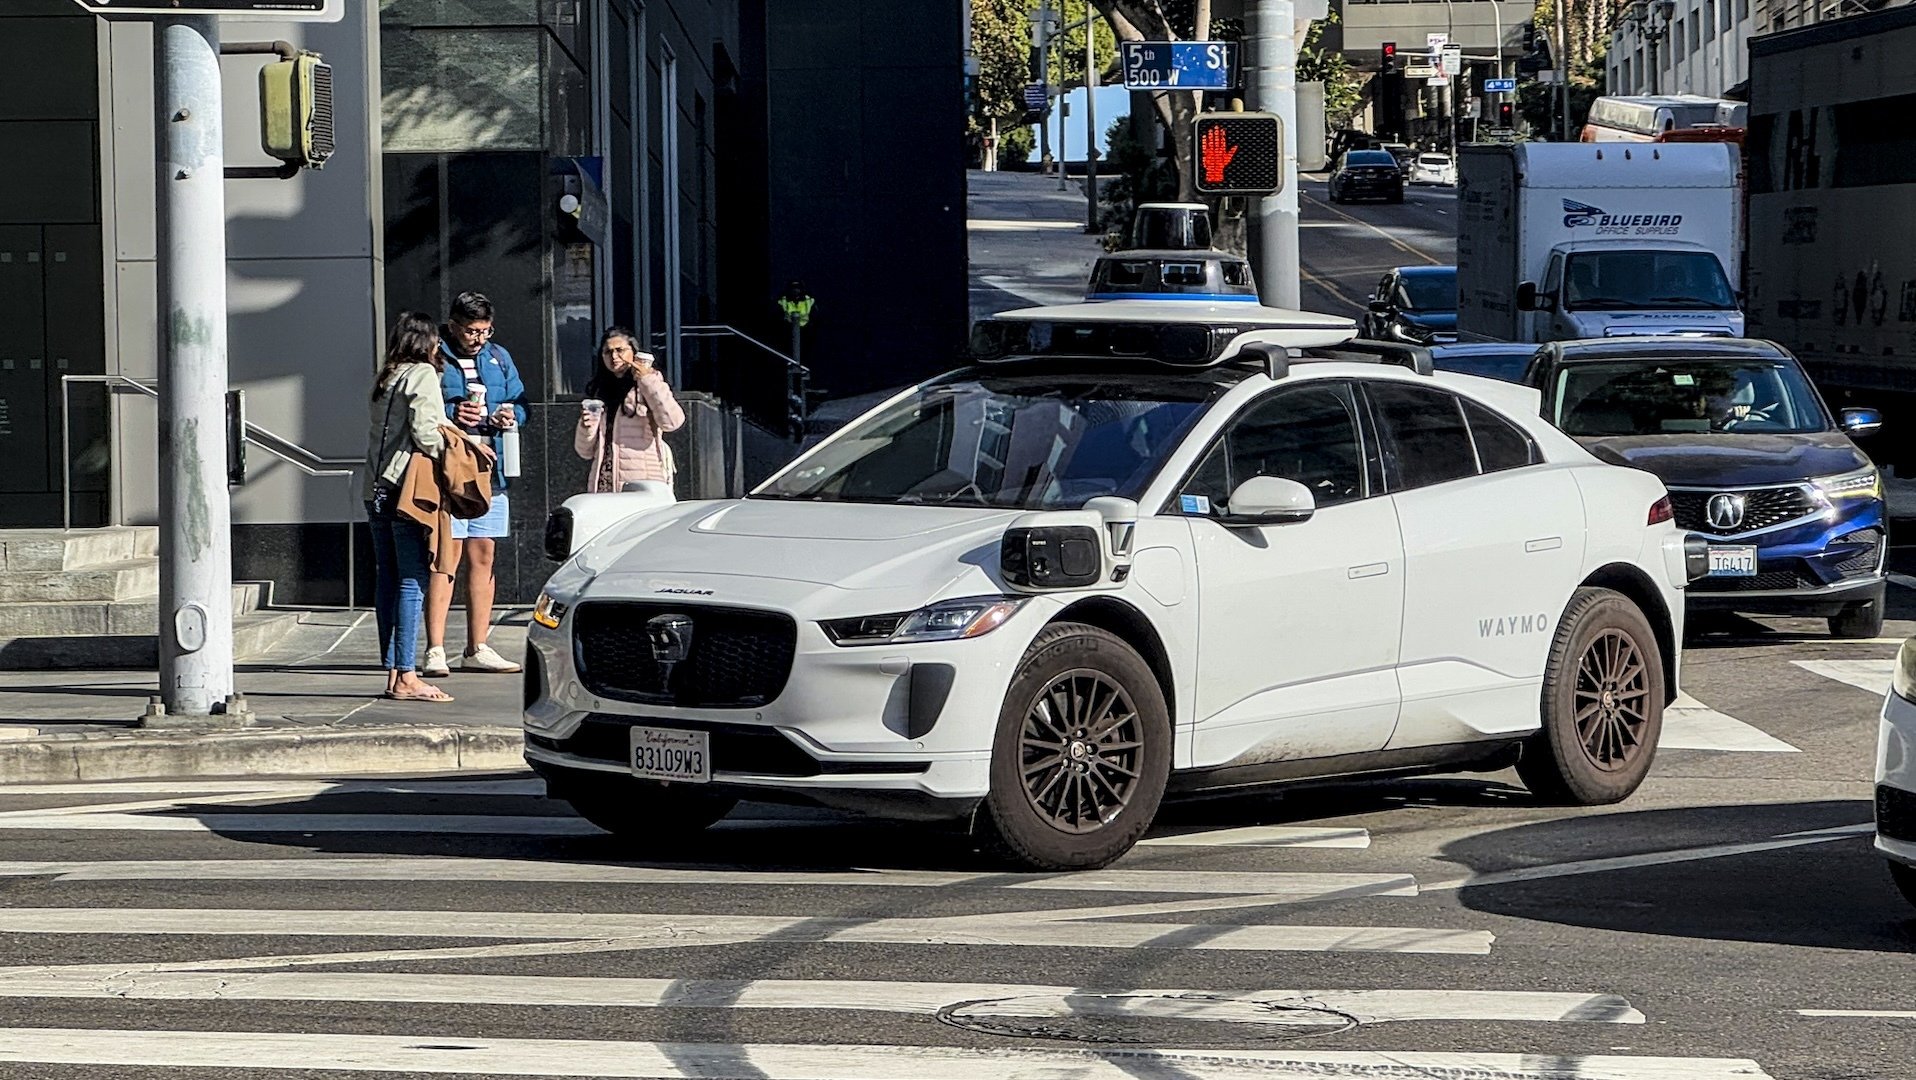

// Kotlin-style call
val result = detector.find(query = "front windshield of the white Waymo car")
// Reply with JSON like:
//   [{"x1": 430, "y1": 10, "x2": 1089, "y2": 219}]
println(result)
[{"x1": 753, "y1": 370, "x2": 1230, "y2": 509}]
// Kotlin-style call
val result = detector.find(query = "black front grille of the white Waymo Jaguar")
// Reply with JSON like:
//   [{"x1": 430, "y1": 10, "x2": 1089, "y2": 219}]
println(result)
[{"x1": 573, "y1": 601, "x2": 799, "y2": 709}]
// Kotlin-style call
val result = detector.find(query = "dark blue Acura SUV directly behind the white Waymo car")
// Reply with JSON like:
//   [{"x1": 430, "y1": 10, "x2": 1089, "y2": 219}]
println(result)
[{"x1": 1523, "y1": 337, "x2": 1889, "y2": 638}]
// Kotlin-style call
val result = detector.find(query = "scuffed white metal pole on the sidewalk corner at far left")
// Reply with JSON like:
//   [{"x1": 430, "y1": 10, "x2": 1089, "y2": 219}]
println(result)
[{"x1": 153, "y1": 15, "x2": 234, "y2": 722}]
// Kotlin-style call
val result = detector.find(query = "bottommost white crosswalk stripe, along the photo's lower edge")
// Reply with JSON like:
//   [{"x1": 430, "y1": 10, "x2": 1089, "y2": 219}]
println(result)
[{"x1": 0, "y1": 1028, "x2": 1768, "y2": 1080}]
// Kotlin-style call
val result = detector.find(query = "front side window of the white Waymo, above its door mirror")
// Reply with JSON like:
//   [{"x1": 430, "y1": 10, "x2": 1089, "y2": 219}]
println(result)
[{"x1": 1182, "y1": 383, "x2": 1364, "y2": 513}]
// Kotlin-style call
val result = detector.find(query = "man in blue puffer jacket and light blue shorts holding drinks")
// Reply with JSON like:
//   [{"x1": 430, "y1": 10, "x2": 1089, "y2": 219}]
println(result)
[{"x1": 420, "y1": 293, "x2": 525, "y2": 676}]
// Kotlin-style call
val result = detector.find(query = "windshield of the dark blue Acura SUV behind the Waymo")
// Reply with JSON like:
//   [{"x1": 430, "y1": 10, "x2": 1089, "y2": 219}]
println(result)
[{"x1": 1554, "y1": 360, "x2": 1830, "y2": 437}]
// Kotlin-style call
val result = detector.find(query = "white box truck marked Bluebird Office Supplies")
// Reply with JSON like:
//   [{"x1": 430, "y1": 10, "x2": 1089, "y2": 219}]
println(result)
[{"x1": 1456, "y1": 142, "x2": 1744, "y2": 341}]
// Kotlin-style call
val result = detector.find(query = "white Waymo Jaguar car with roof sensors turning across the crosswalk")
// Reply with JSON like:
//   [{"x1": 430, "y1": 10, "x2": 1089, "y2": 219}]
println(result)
[{"x1": 525, "y1": 301, "x2": 1705, "y2": 869}]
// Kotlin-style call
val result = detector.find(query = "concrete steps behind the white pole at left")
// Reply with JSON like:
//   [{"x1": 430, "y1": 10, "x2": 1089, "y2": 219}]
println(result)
[{"x1": 0, "y1": 529, "x2": 299, "y2": 670}]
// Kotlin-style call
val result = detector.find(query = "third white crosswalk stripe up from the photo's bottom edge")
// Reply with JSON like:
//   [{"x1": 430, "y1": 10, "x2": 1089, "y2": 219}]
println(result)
[{"x1": 0, "y1": 908, "x2": 1493, "y2": 956}]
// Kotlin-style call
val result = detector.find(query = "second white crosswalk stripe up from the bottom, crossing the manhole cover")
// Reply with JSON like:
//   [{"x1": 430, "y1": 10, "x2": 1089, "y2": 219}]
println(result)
[{"x1": 0, "y1": 971, "x2": 1644, "y2": 1026}]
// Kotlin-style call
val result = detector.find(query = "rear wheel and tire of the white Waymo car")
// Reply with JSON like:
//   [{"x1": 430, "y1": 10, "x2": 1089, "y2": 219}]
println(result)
[{"x1": 1517, "y1": 588, "x2": 1665, "y2": 806}]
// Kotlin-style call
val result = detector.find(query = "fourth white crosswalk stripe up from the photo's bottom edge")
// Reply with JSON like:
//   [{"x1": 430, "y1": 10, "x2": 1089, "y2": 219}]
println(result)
[{"x1": 0, "y1": 858, "x2": 1418, "y2": 902}]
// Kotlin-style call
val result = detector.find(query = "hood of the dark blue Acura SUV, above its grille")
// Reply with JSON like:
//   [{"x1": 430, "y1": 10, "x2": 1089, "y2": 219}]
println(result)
[{"x1": 1577, "y1": 431, "x2": 1870, "y2": 488}]
